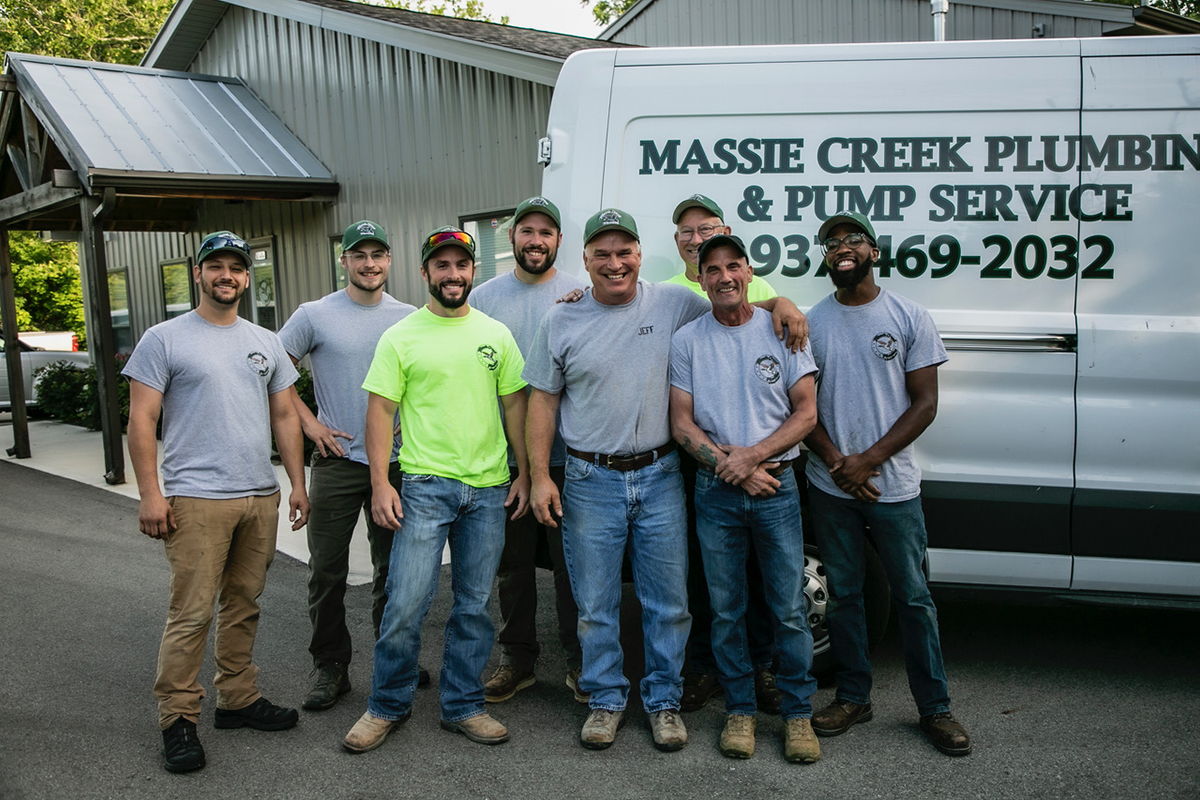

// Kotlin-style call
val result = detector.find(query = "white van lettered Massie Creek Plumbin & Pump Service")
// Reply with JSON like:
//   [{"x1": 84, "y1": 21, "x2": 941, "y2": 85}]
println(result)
[{"x1": 540, "y1": 36, "x2": 1200, "y2": 623}]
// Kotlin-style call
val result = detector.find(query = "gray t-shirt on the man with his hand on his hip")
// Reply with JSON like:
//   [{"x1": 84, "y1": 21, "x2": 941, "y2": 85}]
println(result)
[{"x1": 280, "y1": 291, "x2": 416, "y2": 464}]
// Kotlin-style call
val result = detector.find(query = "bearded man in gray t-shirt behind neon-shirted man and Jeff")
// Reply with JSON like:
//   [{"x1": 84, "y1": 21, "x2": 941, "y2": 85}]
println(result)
[{"x1": 470, "y1": 197, "x2": 588, "y2": 703}]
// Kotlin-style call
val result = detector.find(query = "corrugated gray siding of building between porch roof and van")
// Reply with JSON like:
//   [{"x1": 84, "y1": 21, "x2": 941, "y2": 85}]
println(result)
[{"x1": 109, "y1": 7, "x2": 551, "y2": 336}]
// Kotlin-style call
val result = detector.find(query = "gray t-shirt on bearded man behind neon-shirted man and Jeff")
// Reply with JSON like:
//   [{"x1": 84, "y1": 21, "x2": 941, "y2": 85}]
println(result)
[{"x1": 470, "y1": 271, "x2": 587, "y2": 467}]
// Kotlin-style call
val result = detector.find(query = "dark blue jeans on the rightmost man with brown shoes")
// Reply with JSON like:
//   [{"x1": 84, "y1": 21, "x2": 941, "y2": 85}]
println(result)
[{"x1": 809, "y1": 487, "x2": 950, "y2": 716}]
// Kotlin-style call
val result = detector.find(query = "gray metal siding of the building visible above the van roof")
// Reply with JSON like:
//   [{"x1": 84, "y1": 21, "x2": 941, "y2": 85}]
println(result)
[{"x1": 612, "y1": 0, "x2": 1120, "y2": 47}]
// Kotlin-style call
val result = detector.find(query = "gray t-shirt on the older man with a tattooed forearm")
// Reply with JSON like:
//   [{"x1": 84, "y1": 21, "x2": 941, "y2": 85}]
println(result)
[{"x1": 671, "y1": 308, "x2": 817, "y2": 461}]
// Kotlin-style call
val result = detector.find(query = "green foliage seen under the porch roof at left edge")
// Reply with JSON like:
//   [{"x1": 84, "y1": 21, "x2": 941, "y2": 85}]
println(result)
[{"x1": 0, "y1": 230, "x2": 86, "y2": 344}]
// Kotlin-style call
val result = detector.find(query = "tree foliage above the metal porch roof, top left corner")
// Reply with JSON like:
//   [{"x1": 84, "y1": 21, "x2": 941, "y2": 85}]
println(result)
[{"x1": 0, "y1": 0, "x2": 174, "y2": 64}]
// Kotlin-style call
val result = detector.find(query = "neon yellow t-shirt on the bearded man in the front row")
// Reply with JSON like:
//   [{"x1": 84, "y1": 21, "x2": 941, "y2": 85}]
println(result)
[{"x1": 362, "y1": 307, "x2": 526, "y2": 488}]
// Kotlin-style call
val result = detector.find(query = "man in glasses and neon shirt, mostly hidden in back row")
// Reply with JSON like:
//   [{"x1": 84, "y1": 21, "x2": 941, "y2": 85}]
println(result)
[{"x1": 666, "y1": 194, "x2": 784, "y2": 714}]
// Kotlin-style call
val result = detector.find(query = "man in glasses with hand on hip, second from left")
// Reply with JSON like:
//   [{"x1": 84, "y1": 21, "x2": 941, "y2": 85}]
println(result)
[{"x1": 280, "y1": 219, "x2": 428, "y2": 711}]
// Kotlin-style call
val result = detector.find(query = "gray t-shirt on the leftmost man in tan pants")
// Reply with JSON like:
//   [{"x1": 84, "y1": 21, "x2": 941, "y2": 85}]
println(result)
[{"x1": 121, "y1": 311, "x2": 298, "y2": 500}]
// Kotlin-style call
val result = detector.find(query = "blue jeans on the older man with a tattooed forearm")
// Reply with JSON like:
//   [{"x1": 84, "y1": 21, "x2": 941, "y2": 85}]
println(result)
[{"x1": 696, "y1": 469, "x2": 817, "y2": 720}]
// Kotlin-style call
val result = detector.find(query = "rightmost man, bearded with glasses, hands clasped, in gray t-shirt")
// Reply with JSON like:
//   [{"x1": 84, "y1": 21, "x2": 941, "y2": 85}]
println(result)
[{"x1": 804, "y1": 211, "x2": 971, "y2": 756}]
